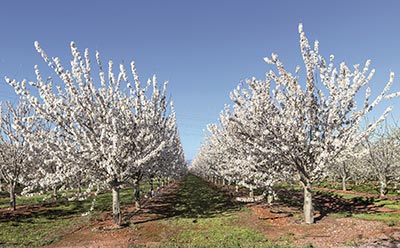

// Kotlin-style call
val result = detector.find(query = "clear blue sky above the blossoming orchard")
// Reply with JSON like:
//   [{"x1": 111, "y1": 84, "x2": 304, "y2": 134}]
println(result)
[{"x1": 0, "y1": 0, "x2": 400, "y2": 159}]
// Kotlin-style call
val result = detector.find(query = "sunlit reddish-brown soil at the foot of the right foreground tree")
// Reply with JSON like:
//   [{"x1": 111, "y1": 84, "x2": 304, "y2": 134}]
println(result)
[{"x1": 244, "y1": 204, "x2": 400, "y2": 247}]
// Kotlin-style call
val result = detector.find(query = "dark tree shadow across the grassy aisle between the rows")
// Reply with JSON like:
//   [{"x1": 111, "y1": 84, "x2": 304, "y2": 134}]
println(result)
[{"x1": 132, "y1": 174, "x2": 241, "y2": 224}]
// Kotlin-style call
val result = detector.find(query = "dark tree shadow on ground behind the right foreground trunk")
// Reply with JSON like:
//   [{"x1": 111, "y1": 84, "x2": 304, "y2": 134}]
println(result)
[{"x1": 278, "y1": 188, "x2": 378, "y2": 221}]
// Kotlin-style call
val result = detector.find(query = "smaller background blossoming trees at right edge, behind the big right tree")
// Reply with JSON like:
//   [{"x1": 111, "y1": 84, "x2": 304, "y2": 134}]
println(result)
[{"x1": 328, "y1": 123, "x2": 400, "y2": 196}]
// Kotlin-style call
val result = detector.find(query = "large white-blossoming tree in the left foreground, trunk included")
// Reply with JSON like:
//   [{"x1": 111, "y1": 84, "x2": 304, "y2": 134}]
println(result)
[{"x1": 6, "y1": 42, "x2": 185, "y2": 224}]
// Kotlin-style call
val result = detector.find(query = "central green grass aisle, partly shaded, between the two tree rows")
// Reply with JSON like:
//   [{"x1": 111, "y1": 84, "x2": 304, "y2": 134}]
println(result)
[{"x1": 156, "y1": 175, "x2": 296, "y2": 248}]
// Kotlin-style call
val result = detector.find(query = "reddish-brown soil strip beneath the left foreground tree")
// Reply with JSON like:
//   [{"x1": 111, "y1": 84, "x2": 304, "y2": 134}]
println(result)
[{"x1": 48, "y1": 183, "x2": 179, "y2": 247}]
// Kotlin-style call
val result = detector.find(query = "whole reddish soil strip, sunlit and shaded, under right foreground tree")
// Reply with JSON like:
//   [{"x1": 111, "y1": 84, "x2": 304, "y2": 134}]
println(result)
[{"x1": 211, "y1": 186, "x2": 400, "y2": 248}]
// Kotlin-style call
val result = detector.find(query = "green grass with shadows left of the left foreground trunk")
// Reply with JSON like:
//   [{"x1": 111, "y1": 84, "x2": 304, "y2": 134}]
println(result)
[{"x1": 0, "y1": 182, "x2": 155, "y2": 247}]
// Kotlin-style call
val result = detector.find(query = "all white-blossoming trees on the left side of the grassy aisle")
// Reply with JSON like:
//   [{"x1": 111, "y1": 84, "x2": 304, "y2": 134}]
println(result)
[{"x1": 0, "y1": 42, "x2": 186, "y2": 224}]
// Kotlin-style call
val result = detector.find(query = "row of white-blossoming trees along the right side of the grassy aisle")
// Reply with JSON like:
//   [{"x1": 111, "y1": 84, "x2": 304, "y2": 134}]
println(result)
[{"x1": 191, "y1": 24, "x2": 398, "y2": 223}]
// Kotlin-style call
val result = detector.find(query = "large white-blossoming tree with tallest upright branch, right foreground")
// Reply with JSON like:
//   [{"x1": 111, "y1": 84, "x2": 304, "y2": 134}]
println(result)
[{"x1": 192, "y1": 24, "x2": 394, "y2": 224}]
